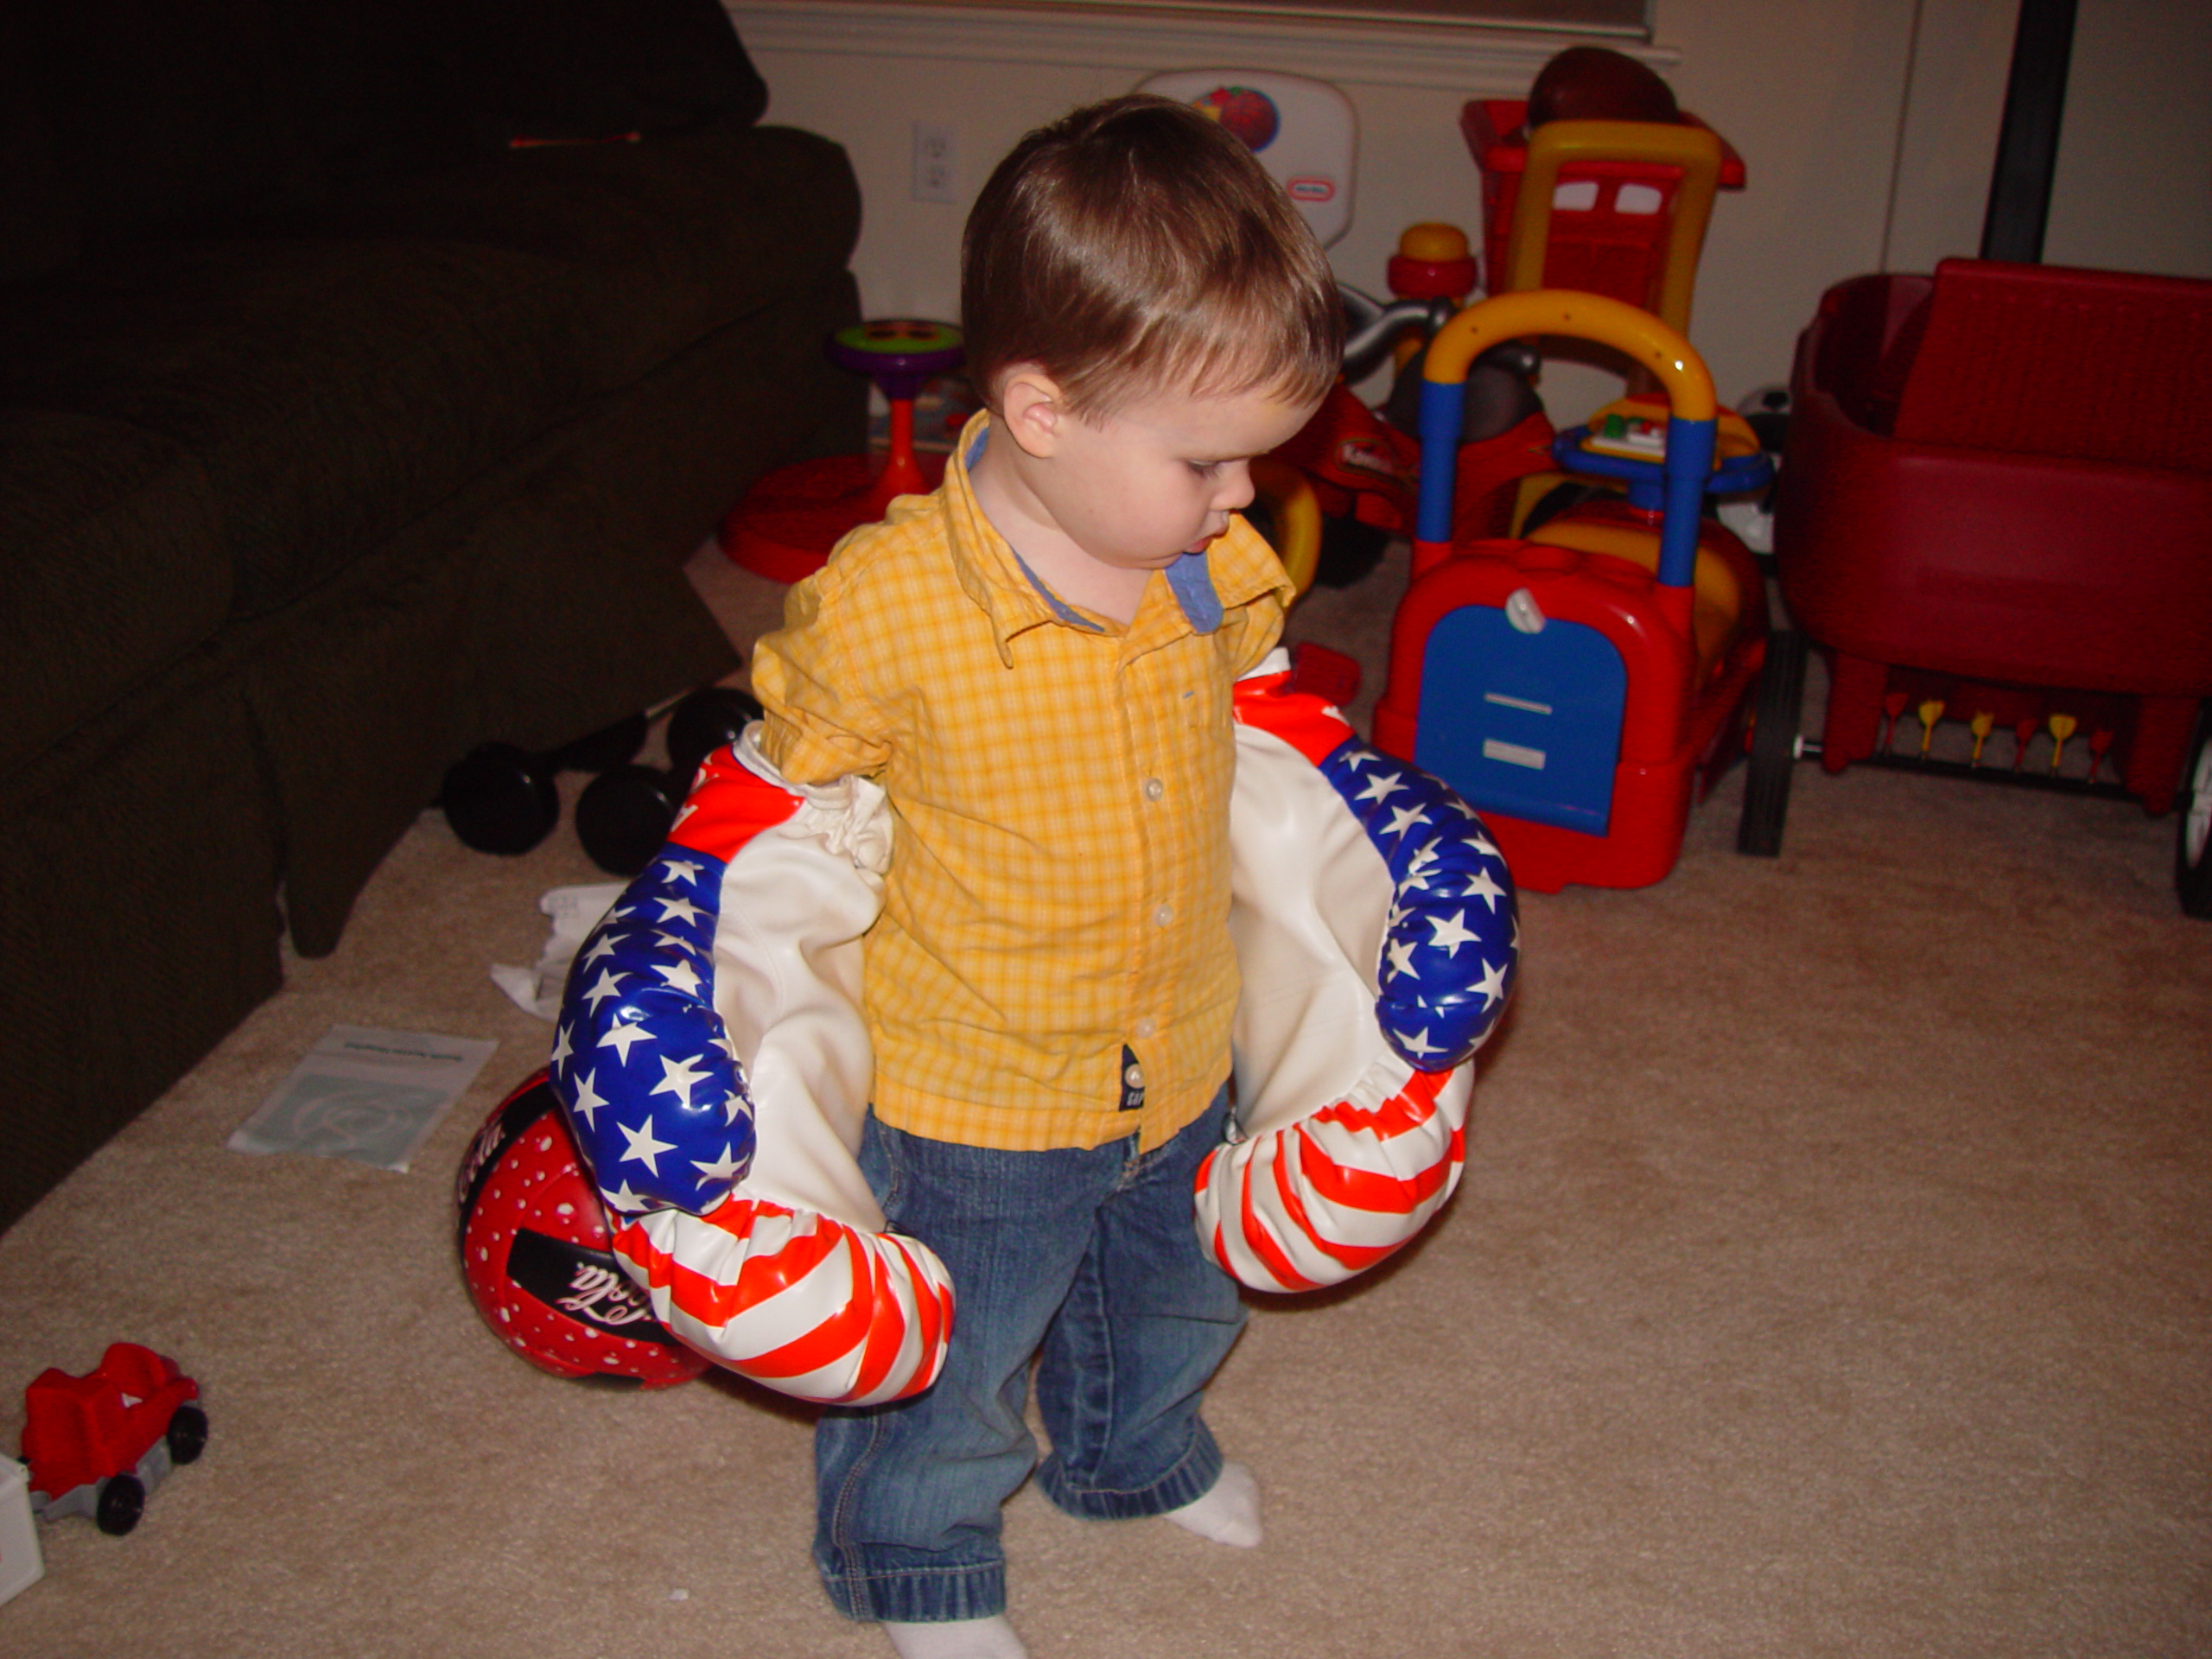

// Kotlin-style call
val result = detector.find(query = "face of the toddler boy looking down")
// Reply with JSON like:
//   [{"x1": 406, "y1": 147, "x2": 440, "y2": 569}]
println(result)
[{"x1": 1035, "y1": 390, "x2": 1314, "y2": 570}]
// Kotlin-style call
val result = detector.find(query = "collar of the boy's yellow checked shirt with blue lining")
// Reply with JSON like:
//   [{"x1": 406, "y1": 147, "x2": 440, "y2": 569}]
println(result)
[{"x1": 943, "y1": 414, "x2": 1296, "y2": 666}]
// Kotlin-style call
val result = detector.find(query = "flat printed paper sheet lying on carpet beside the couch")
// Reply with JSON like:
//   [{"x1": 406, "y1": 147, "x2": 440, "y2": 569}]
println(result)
[{"x1": 228, "y1": 1027, "x2": 500, "y2": 1173}]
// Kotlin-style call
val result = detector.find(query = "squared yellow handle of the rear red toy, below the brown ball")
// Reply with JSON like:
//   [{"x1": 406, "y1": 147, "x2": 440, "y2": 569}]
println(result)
[{"x1": 1497, "y1": 122, "x2": 1726, "y2": 329}]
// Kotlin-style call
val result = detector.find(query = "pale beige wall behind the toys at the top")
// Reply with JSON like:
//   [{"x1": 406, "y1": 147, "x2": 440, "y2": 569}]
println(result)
[{"x1": 730, "y1": 0, "x2": 2212, "y2": 416}]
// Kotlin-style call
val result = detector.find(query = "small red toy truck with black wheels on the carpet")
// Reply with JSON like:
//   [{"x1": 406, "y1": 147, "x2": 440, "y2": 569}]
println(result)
[{"x1": 22, "y1": 1343, "x2": 208, "y2": 1537}]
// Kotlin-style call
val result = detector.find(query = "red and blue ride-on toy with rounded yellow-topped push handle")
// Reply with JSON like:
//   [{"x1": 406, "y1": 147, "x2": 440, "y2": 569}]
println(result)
[{"x1": 1374, "y1": 289, "x2": 1787, "y2": 892}]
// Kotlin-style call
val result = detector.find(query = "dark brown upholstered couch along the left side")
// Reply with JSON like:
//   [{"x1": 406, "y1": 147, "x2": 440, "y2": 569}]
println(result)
[{"x1": 0, "y1": 0, "x2": 865, "y2": 1225}]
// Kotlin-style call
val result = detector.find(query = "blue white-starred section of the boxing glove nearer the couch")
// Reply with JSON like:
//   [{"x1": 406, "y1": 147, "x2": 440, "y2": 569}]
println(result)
[{"x1": 550, "y1": 845, "x2": 752, "y2": 1214}]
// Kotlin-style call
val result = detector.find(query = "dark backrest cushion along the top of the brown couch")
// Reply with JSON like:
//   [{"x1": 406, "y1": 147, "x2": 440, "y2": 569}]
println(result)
[{"x1": 0, "y1": 0, "x2": 767, "y2": 259}]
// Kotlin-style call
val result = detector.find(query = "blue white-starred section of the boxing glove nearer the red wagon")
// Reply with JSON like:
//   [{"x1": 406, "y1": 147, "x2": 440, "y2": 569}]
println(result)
[{"x1": 1320, "y1": 736, "x2": 1520, "y2": 1071}]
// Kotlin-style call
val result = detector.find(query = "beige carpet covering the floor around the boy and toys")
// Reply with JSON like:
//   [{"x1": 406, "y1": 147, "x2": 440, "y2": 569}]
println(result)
[{"x1": 0, "y1": 539, "x2": 2212, "y2": 1659}]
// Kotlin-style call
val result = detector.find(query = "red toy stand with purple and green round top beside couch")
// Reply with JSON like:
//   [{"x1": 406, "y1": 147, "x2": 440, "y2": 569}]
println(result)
[{"x1": 719, "y1": 319, "x2": 963, "y2": 582}]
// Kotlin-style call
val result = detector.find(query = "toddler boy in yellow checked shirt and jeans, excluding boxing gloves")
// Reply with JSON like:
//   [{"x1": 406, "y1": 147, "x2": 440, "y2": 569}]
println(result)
[{"x1": 752, "y1": 98, "x2": 1343, "y2": 1659}]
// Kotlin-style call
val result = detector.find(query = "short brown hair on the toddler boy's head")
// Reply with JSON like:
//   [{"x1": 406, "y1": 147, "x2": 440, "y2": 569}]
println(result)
[{"x1": 960, "y1": 93, "x2": 1344, "y2": 414}]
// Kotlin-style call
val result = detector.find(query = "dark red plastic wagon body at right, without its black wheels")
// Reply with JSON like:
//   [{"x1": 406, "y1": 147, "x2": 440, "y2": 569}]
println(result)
[{"x1": 1774, "y1": 259, "x2": 2212, "y2": 913}]
